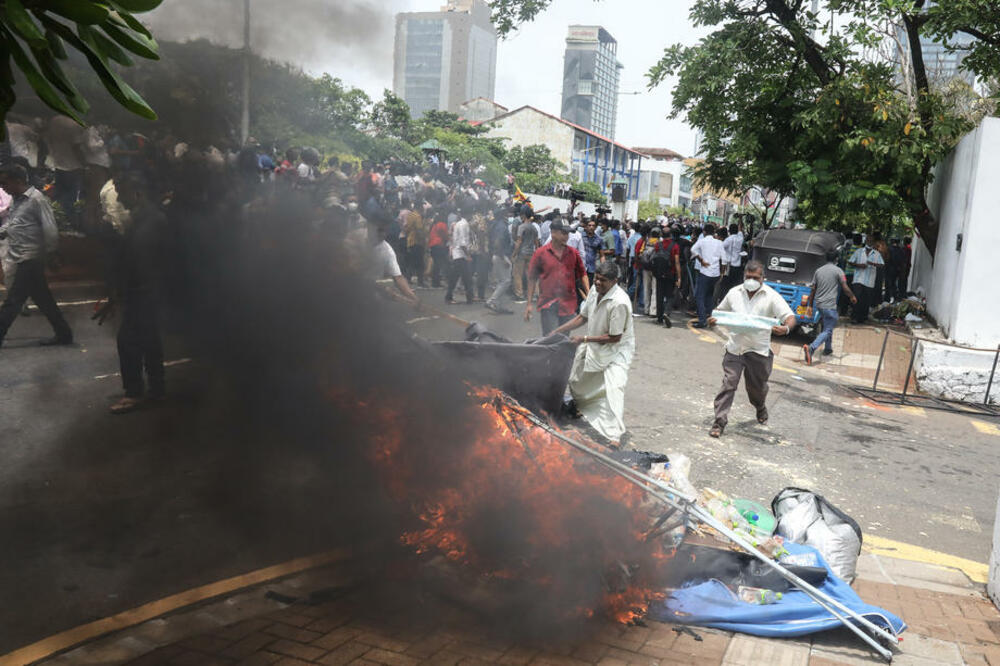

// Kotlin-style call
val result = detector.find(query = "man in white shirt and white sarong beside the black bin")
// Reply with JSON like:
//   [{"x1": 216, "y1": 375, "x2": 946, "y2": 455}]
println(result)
[{"x1": 553, "y1": 262, "x2": 635, "y2": 443}]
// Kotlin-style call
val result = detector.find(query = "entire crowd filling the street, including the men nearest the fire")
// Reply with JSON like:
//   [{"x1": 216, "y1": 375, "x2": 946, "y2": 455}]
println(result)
[{"x1": 0, "y1": 116, "x2": 910, "y2": 442}]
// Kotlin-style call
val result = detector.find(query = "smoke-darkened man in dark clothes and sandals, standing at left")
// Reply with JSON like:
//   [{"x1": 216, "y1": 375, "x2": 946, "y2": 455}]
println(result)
[{"x1": 105, "y1": 174, "x2": 167, "y2": 414}]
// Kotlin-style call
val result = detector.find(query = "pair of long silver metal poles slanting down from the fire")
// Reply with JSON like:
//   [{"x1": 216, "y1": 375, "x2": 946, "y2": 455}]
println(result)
[{"x1": 508, "y1": 403, "x2": 899, "y2": 660}]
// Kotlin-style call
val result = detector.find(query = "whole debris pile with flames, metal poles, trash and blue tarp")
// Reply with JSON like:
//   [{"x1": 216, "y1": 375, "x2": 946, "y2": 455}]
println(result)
[{"x1": 359, "y1": 388, "x2": 905, "y2": 658}]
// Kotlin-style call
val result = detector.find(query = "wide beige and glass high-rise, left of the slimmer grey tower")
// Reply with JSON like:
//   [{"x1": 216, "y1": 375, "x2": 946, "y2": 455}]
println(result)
[{"x1": 393, "y1": 0, "x2": 497, "y2": 117}]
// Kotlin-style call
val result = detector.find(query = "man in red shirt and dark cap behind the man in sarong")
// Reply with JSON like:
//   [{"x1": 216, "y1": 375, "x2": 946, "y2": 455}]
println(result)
[{"x1": 524, "y1": 219, "x2": 590, "y2": 335}]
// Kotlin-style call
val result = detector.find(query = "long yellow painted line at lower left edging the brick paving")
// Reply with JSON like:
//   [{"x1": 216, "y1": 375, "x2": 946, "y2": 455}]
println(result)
[{"x1": 0, "y1": 549, "x2": 348, "y2": 666}]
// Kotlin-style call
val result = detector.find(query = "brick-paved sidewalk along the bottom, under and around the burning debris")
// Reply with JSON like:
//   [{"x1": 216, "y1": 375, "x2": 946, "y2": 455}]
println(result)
[{"x1": 31, "y1": 554, "x2": 1000, "y2": 666}]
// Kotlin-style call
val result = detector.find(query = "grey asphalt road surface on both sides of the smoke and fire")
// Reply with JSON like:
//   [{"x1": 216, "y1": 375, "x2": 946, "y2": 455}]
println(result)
[{"x1": 0, "y1": 282, "x2": 1000, "y2": 654}]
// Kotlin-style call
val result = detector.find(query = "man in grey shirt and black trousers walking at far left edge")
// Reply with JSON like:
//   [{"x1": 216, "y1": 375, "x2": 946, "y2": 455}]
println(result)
[{"x1": 0, "y1": 164, "x2": 73, "y2": 346}]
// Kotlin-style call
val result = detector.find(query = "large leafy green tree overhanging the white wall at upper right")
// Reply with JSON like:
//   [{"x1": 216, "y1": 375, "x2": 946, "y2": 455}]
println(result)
[{"x1": 494, "y1": 0, "x2": 1000, "y2": 253}]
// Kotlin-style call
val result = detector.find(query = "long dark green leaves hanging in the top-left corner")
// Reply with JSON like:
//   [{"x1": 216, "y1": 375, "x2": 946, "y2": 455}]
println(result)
[{"x1": 0, "y1": 0, "x2": 162, "y2": 133}]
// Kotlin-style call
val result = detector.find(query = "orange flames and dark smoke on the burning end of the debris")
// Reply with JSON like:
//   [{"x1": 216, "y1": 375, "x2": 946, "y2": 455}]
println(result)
[{"x1": 366, "y1": 389, "x2": 675, "y2": 623}]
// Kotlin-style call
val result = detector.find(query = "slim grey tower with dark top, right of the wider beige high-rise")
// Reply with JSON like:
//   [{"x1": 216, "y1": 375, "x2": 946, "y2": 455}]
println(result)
[{"x1": 562, "y1": 25, "x2": 622, "y2": 139}]
